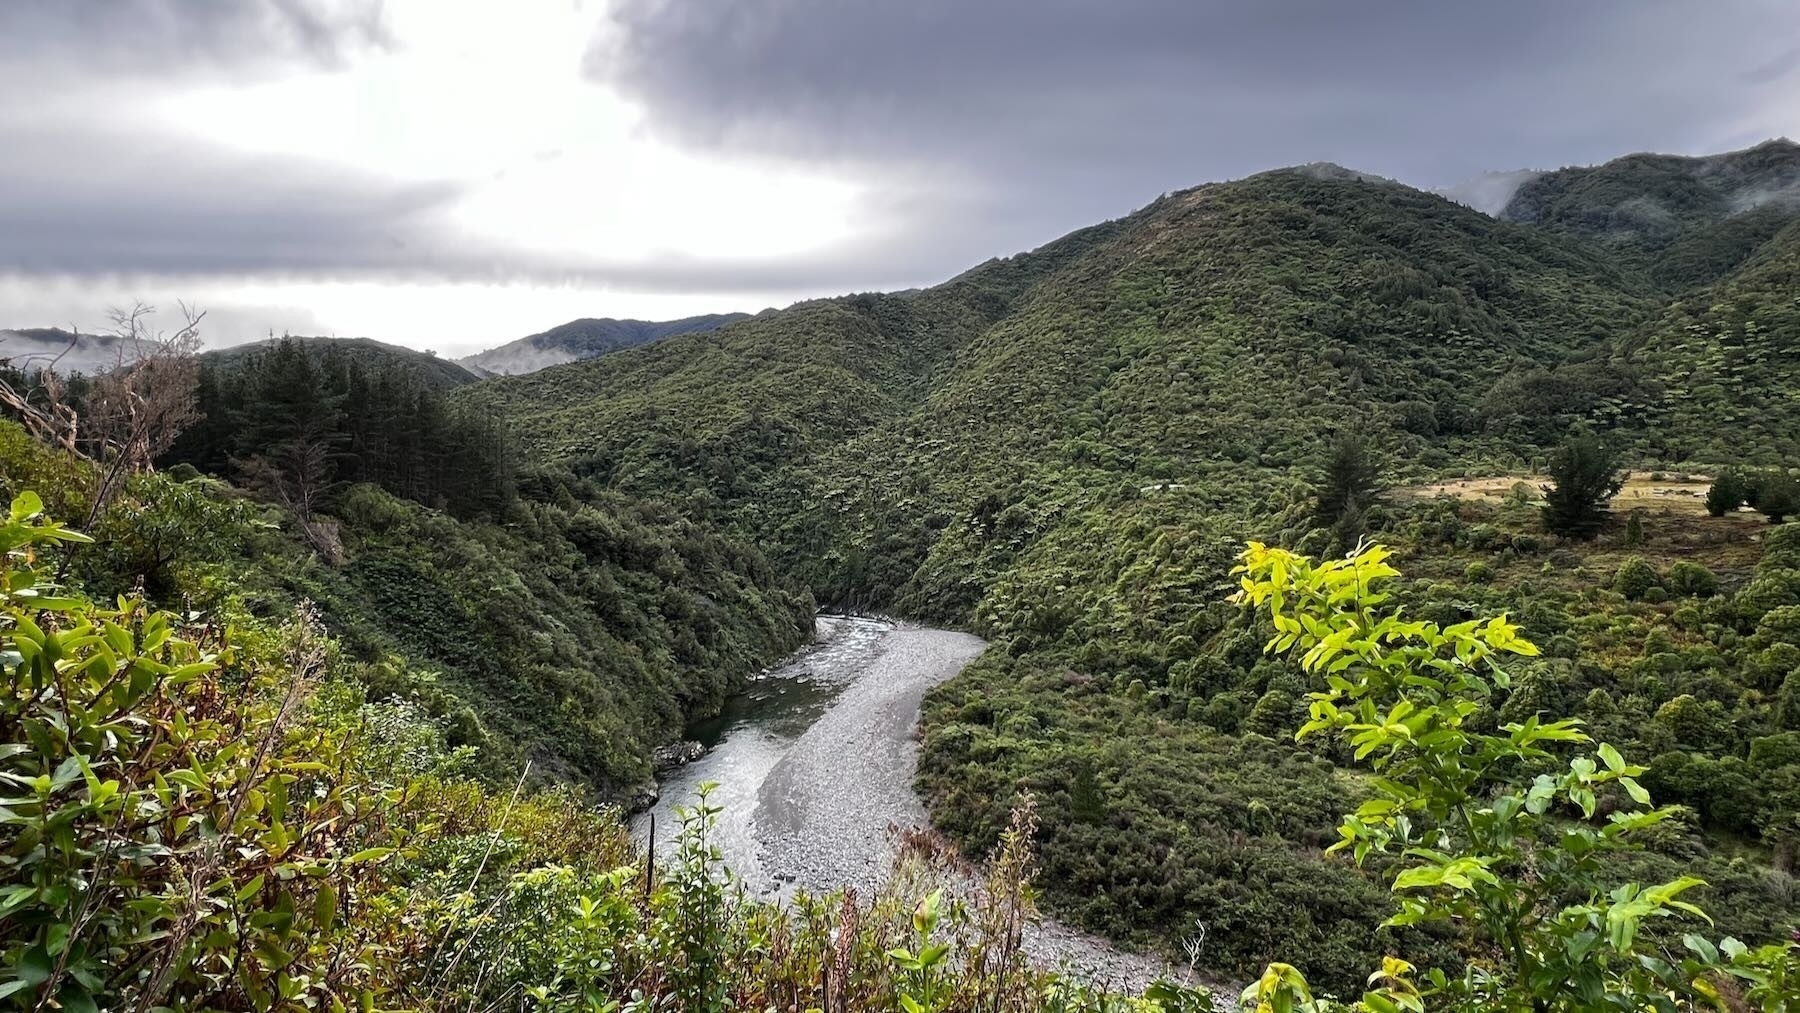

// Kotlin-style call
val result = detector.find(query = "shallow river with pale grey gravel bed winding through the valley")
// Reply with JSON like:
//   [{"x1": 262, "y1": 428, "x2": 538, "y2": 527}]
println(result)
[{"x1": 632, "y1": 615, "x2": 1233, "y2": 1009}]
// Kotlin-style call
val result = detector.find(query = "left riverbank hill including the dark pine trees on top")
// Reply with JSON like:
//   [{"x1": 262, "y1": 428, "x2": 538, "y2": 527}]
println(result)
[{"x1": 133, "y1": 338, "x2": 812, "y2": 799}]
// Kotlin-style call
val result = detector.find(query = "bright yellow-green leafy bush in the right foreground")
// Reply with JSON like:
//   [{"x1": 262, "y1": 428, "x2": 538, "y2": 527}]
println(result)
[{"x1": 1238, "y1": 543, "x2": 1800, "y2": 1011}]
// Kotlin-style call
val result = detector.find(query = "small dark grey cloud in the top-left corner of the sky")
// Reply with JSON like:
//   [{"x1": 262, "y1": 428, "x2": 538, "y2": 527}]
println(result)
[{"x1": 0, "y1": 0, "x2": 389, "y2": 76}]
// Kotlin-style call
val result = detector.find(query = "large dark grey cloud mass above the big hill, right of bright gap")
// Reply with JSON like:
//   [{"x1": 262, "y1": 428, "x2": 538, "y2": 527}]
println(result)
[{"x1": 587, "y1": 0, "x2": 1800, "y2": 268}]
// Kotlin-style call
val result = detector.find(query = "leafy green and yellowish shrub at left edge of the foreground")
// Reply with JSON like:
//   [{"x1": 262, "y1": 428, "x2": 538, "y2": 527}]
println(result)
[{"x1": 0, "y1": 493, "x2": 401, "y2": 1009}]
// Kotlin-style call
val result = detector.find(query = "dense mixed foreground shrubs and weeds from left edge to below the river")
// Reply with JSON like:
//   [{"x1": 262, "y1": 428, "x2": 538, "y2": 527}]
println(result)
[{"x1": 0, "y1": 493, "x2": 1211, "y2": 1013}]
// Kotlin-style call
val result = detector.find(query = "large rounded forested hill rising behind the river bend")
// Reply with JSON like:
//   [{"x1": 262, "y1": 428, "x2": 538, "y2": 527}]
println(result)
[{"x1": 457, "y1": 171, "x2": 1658, "y2": 619}]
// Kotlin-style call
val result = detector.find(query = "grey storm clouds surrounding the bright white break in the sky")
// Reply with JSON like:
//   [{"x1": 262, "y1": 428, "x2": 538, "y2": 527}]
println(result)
[{"x1": 0, "y1": 0, "x2": 1800, "y2": 291}]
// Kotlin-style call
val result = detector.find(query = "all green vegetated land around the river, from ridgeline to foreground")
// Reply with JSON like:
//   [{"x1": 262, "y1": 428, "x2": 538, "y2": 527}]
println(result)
[{"x1": 0, "y1": 142, "x2": 1800, "y2": 1013}]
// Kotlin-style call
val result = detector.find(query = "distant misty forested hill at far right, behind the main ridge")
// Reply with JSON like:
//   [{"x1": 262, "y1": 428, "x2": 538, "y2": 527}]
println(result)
[{"x1": 1499, "y1": 139, "x2": 1800, "y2": 291}]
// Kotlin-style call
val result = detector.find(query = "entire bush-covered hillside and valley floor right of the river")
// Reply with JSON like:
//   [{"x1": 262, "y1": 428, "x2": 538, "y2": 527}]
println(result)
[{"x1": 452, "y1": 150, "x2": 1800, "y2": 990}]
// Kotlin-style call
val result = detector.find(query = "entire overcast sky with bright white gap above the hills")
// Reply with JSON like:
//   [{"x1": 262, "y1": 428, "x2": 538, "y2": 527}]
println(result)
[{"x1": 0, "y1": 0, "x2": 1800, "y2": 354}]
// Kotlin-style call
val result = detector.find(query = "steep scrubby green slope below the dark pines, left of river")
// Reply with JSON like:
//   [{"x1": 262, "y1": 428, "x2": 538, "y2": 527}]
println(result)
[{"x1": 0, "y1": 419, "x2": 812, "y2": 801}]
